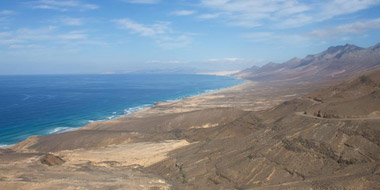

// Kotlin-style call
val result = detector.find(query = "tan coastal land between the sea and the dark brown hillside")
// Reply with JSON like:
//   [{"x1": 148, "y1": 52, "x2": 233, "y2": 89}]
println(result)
[{"x1": 0, "y1": 75, "x2": 330, "y2": 189}]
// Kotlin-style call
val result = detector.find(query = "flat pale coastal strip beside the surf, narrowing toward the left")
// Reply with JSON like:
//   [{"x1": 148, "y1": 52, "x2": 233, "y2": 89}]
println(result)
[{"x1": 0, "y1": 75, "x2": 326, "y2": 149}]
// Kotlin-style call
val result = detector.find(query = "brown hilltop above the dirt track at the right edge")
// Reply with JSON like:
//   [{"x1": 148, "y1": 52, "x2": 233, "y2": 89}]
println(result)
[{"x1": 305, "y1": 70, "x2": 380, "y2": 119}]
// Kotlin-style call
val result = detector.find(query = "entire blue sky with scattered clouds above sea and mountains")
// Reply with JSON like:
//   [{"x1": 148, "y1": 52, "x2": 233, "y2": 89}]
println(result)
[{"x1": 0, "y1": 0, "x2": 380, "y2": 75}]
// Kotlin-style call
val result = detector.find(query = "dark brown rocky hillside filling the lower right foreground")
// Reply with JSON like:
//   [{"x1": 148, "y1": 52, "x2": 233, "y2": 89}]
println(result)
[{"x1": 149, "y1": 70, "x2": 380, "y2": 189}]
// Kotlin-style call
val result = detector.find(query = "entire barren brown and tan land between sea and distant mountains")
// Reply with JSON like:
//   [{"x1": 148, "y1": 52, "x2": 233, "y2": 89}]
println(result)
[{"x1": 0, "y1": 68, "x2": 380, "y2": 190}]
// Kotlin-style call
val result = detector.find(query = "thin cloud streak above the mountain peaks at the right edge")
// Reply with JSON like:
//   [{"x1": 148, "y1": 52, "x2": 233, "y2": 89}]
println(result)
[{"x1": 308, "y1": 18, "x2": 380, "y2": 38}]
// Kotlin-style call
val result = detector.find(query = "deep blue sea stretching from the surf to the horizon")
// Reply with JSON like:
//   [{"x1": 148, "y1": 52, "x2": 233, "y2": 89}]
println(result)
[{"x1": 0, "y1": 74, "x2": 242, "y2": 147}]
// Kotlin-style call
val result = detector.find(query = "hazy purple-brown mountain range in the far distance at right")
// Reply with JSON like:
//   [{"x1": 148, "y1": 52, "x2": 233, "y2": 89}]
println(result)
[{"x1": 235, "y1": 43, "x2": 380, "y2": 82}]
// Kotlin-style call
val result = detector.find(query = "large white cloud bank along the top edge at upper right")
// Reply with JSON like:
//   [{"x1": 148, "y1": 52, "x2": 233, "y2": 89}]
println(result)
[{"x1": 199, "y1": 0, "x2": 380, "y2": 28}]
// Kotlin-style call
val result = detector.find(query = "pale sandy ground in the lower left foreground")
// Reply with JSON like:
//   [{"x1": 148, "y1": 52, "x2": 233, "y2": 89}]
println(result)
[{"x1": 0, "y1": 140, "x2": 190, "y2": 190}]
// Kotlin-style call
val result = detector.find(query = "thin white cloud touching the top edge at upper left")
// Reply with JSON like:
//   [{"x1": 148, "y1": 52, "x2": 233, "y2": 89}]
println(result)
[{"x1": 30, "y1": 0, "x2": 99, "y2": 11}]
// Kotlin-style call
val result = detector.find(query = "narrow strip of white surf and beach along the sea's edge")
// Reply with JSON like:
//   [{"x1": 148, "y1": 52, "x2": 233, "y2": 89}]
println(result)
[{"x1": 0, "y1": 76, "x2": 246, "y2": 149}]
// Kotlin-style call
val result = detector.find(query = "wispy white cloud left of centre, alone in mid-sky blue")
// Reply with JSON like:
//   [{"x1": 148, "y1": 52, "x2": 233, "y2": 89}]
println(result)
[{"x1": 113, "y1": 18, "x2": 192, "y2": 49}]
